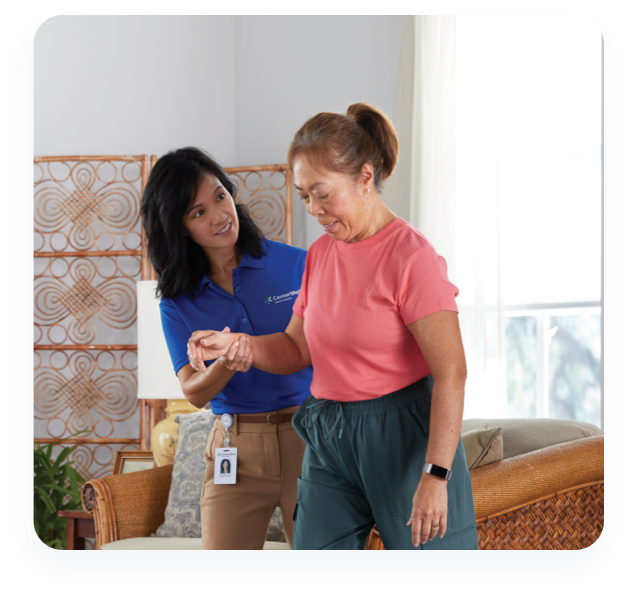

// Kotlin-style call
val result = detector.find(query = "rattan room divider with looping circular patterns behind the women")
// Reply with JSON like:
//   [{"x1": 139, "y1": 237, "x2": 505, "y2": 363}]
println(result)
[{"x1": 33, "y1": 155, "x2": 292, "y2": 480}]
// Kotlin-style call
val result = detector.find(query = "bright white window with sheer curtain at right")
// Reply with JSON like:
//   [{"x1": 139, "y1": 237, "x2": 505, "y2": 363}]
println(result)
[{"x1": 410, "y1": 15, "x2": 602, "y2": 424}]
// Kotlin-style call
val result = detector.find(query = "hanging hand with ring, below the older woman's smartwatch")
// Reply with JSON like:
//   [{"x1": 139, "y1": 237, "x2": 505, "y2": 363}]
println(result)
[{"x1": 407, "y1": 473, "x2": 447, "y2": 547}]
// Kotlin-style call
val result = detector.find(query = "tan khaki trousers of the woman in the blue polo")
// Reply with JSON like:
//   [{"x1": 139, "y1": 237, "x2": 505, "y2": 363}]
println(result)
[{"x1": 200, "y1": 407, "x2": 305, "y2": 550}]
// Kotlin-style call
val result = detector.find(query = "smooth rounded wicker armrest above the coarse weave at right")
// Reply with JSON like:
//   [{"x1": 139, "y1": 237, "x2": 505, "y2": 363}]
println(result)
[{"x1": 471, "y1": 436, "x2": 604, "y2": 523}]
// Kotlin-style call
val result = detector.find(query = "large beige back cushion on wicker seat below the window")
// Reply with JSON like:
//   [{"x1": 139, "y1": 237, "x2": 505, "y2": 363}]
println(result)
[{"x1": 462, "y1": 418, "x2": 602, "y2": 459}]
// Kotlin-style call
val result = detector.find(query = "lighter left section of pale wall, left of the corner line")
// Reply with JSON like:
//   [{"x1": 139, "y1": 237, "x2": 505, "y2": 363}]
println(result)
[{"x1": 33, "y1": 14, "x2": 237, "y2": 165}]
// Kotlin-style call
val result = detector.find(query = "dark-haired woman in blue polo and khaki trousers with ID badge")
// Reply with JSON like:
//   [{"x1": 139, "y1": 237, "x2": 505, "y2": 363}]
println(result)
[{"x1": 142, "y1": 147, "x2": 312, "y2": 550}]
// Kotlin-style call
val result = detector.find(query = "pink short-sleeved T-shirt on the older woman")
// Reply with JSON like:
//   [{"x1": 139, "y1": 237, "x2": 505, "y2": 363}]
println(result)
[{"x1": 294, "y1": 218, "x2": 458, "y2": 401}]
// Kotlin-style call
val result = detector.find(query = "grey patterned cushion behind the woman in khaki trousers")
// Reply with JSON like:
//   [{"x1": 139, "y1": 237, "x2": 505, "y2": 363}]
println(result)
[{"x1": 153, "y1": 409, "x2": 287, "y2": 549}]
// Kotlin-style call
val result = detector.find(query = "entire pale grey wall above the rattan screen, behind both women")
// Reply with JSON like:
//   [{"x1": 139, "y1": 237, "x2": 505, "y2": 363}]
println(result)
[{"x1": 33, "y1": 14, "x2": 402, "y2": 248}]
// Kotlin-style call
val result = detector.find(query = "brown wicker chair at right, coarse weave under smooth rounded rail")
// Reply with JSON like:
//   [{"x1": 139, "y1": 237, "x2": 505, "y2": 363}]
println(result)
[{"x1": 366, "y1": 436, "x2": 604, "y2": 550}]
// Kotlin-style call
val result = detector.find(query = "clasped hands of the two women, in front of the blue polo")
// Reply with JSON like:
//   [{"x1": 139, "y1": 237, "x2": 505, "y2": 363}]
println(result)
[{"x1": 187, "y1": 327, "x2": 254, "y2": 372}]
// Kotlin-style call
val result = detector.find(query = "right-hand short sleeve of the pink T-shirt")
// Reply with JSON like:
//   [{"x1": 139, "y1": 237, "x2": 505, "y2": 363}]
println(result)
[{"x1": 397, "y1": 246, "x2": 458, "y2": 325}]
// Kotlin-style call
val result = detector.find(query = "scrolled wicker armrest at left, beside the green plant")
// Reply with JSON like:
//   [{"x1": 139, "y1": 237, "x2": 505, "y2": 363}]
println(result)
[{"x1": 82, "y1": 465, "x2": 173, "y2": 549}]
